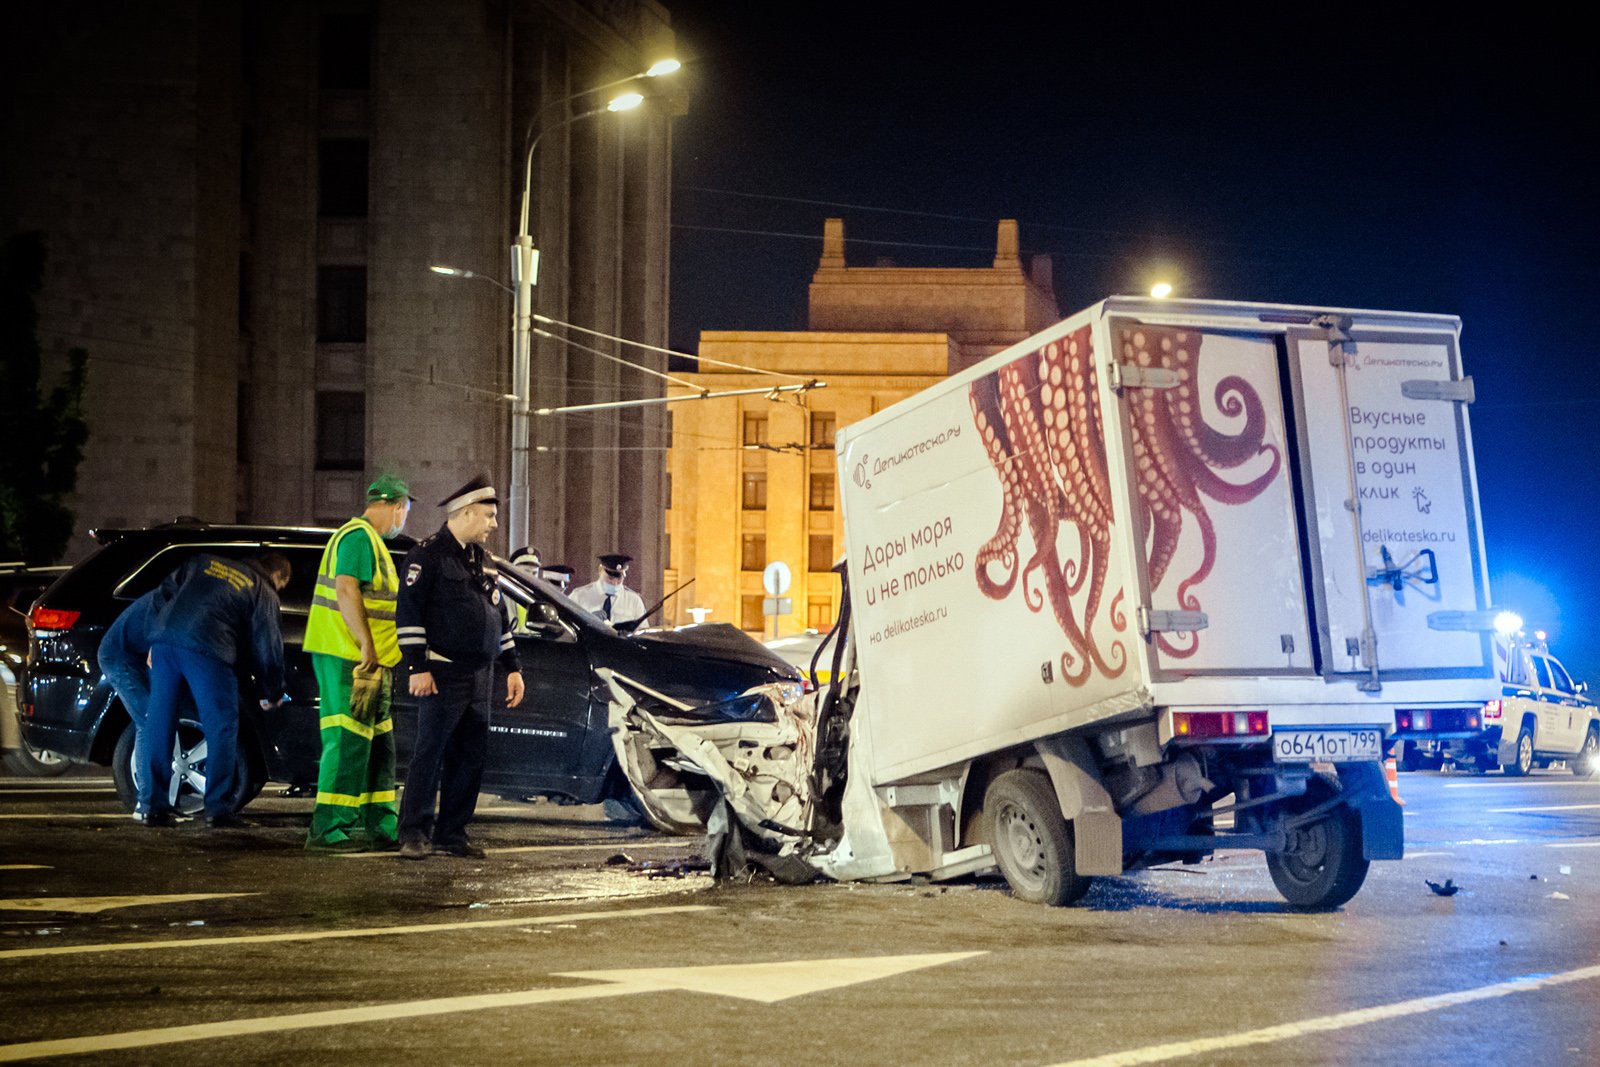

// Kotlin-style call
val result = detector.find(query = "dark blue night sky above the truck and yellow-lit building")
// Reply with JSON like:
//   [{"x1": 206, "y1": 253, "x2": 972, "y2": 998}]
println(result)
[{"x1": 667, "y1": 0, "x2": 1600, "y2": 681}]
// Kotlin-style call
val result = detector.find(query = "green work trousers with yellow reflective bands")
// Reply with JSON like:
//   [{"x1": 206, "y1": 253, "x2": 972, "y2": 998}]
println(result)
[{"x1": 306, "y1": 653, "x2": 398, "y2": 848}]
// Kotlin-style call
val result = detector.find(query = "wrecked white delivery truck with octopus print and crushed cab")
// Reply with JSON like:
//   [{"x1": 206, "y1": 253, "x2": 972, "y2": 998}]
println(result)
[{"x1": 611, "y1": 298, "x2": 1499, "y2": 909}]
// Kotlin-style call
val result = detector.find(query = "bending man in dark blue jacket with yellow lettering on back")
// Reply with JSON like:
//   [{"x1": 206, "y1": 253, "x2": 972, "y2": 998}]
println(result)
[{"x1": 144, "y1": 552, "x2": 290, "y2": 829}]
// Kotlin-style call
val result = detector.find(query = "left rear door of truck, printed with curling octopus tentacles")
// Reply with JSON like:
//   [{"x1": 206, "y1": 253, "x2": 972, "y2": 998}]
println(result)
[{"x1": 1107, "y1": 317, "x2": 1314, "y2": 678}]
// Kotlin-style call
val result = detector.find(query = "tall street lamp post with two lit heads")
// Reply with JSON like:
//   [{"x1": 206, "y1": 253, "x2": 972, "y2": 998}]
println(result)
[{"x1": 506, "y1": 59, "x2": 678, "y2": 550}]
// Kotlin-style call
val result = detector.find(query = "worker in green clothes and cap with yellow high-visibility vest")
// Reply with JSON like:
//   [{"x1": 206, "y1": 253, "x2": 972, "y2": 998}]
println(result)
[{"x1": 304, "y1": 474, "x2": 411, "y2": 853}]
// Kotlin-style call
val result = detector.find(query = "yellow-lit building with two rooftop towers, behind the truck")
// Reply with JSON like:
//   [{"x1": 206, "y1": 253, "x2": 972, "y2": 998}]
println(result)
[{"x1": 664, "y1": 219, "x2": 1061, "y2": 635}]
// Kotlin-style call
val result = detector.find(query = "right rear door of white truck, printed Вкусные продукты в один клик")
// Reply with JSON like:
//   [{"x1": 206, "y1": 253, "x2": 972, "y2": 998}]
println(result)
[{"x1": 1288, "y1": 317, "x2": 1493, "y2": 689}]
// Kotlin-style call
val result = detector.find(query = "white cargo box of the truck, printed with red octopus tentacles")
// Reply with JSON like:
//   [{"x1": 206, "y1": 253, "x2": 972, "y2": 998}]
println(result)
[{"x1": 837, "y1": 298, "x2": 1498, "y2": 785}]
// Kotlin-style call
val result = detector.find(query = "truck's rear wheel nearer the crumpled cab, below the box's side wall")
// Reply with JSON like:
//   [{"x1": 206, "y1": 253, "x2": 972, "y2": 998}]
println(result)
[{"x1": 984, "y1": 769, "x2": 1091, "y2": 907}]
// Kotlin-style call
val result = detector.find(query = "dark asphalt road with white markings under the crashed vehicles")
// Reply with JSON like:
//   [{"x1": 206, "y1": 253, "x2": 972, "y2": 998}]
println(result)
[{"x1": 0, "y1": 771, "x2": 1600, "y2": 1067}]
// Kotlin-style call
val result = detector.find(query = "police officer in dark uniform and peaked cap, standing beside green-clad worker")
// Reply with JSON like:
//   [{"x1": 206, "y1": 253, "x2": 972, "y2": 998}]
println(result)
[{"x1": 397, "y1": 477, "x2": 523, "y2": 859}]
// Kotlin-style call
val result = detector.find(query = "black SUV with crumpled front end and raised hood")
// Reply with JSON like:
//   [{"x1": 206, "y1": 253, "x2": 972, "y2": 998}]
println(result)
[{"x1": 19, "y1": 520, "x2": 800, "y2": 811}]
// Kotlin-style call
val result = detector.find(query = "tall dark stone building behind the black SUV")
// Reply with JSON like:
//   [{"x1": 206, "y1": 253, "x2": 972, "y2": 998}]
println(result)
[{"x1": 0, "y1": 0, "x2": 683, "y2": 595}]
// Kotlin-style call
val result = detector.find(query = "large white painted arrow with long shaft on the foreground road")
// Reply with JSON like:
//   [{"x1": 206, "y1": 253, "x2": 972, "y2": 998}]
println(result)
[{"x1": 0, "y1": 952, "x2": 984, "y2": 1064}]
